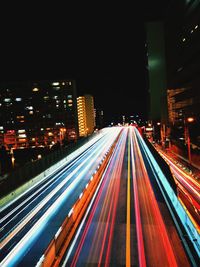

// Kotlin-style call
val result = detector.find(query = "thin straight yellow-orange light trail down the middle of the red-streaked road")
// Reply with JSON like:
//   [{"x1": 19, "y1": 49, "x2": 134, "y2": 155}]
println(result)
[{"x1": 126, "y1": 130, "x2": 131, "y2": 267}]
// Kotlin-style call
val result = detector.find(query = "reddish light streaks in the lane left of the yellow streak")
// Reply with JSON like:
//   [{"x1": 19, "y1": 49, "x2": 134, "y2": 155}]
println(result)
[{"x1": 68, "y1": 129, "x2": 125, "y2": 267}]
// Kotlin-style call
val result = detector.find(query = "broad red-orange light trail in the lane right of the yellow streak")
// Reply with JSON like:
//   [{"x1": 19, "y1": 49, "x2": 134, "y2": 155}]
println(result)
[{"x1": 133, "y1": 129, "x2": 177, "y2": 267}]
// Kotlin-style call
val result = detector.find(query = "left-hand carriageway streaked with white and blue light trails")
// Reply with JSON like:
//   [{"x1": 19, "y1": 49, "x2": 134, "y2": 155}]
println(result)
[{"x1": 0, "y1": 128, "x2": 121, "y2": 267}]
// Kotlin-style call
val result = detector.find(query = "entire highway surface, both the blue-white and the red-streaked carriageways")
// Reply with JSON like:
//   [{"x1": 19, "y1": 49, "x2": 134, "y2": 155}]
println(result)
[{"x1": 0, "y1": 126, "x2": 198, "y2": 267}]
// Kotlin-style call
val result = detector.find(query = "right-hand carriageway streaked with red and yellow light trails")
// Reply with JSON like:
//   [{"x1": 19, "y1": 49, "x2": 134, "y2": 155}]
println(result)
[{"x1": 61, "y1": 127, "x2": 194, "y2": 267}]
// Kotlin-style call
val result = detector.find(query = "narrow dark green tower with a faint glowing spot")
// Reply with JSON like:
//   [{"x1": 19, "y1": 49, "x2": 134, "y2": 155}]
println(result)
[{"x1": 146, "y1": 21, "x2": 167, "y2": 123}]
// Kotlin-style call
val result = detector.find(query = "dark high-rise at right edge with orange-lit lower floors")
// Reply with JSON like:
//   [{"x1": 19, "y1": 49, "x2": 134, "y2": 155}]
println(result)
[{"x1": 165, "y1": 0, "x2": 200, "y2": 147}]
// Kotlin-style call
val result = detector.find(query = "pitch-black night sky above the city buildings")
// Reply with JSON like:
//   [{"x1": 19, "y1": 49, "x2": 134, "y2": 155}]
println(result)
[{"x1": 0, "y1": 1, "x2": 169, "y2": 124}]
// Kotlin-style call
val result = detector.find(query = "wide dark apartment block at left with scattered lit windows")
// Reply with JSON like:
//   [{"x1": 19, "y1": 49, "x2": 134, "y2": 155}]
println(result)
[{"x1": 0, "y1": 80, "x2": 78, "y2": 151}]
